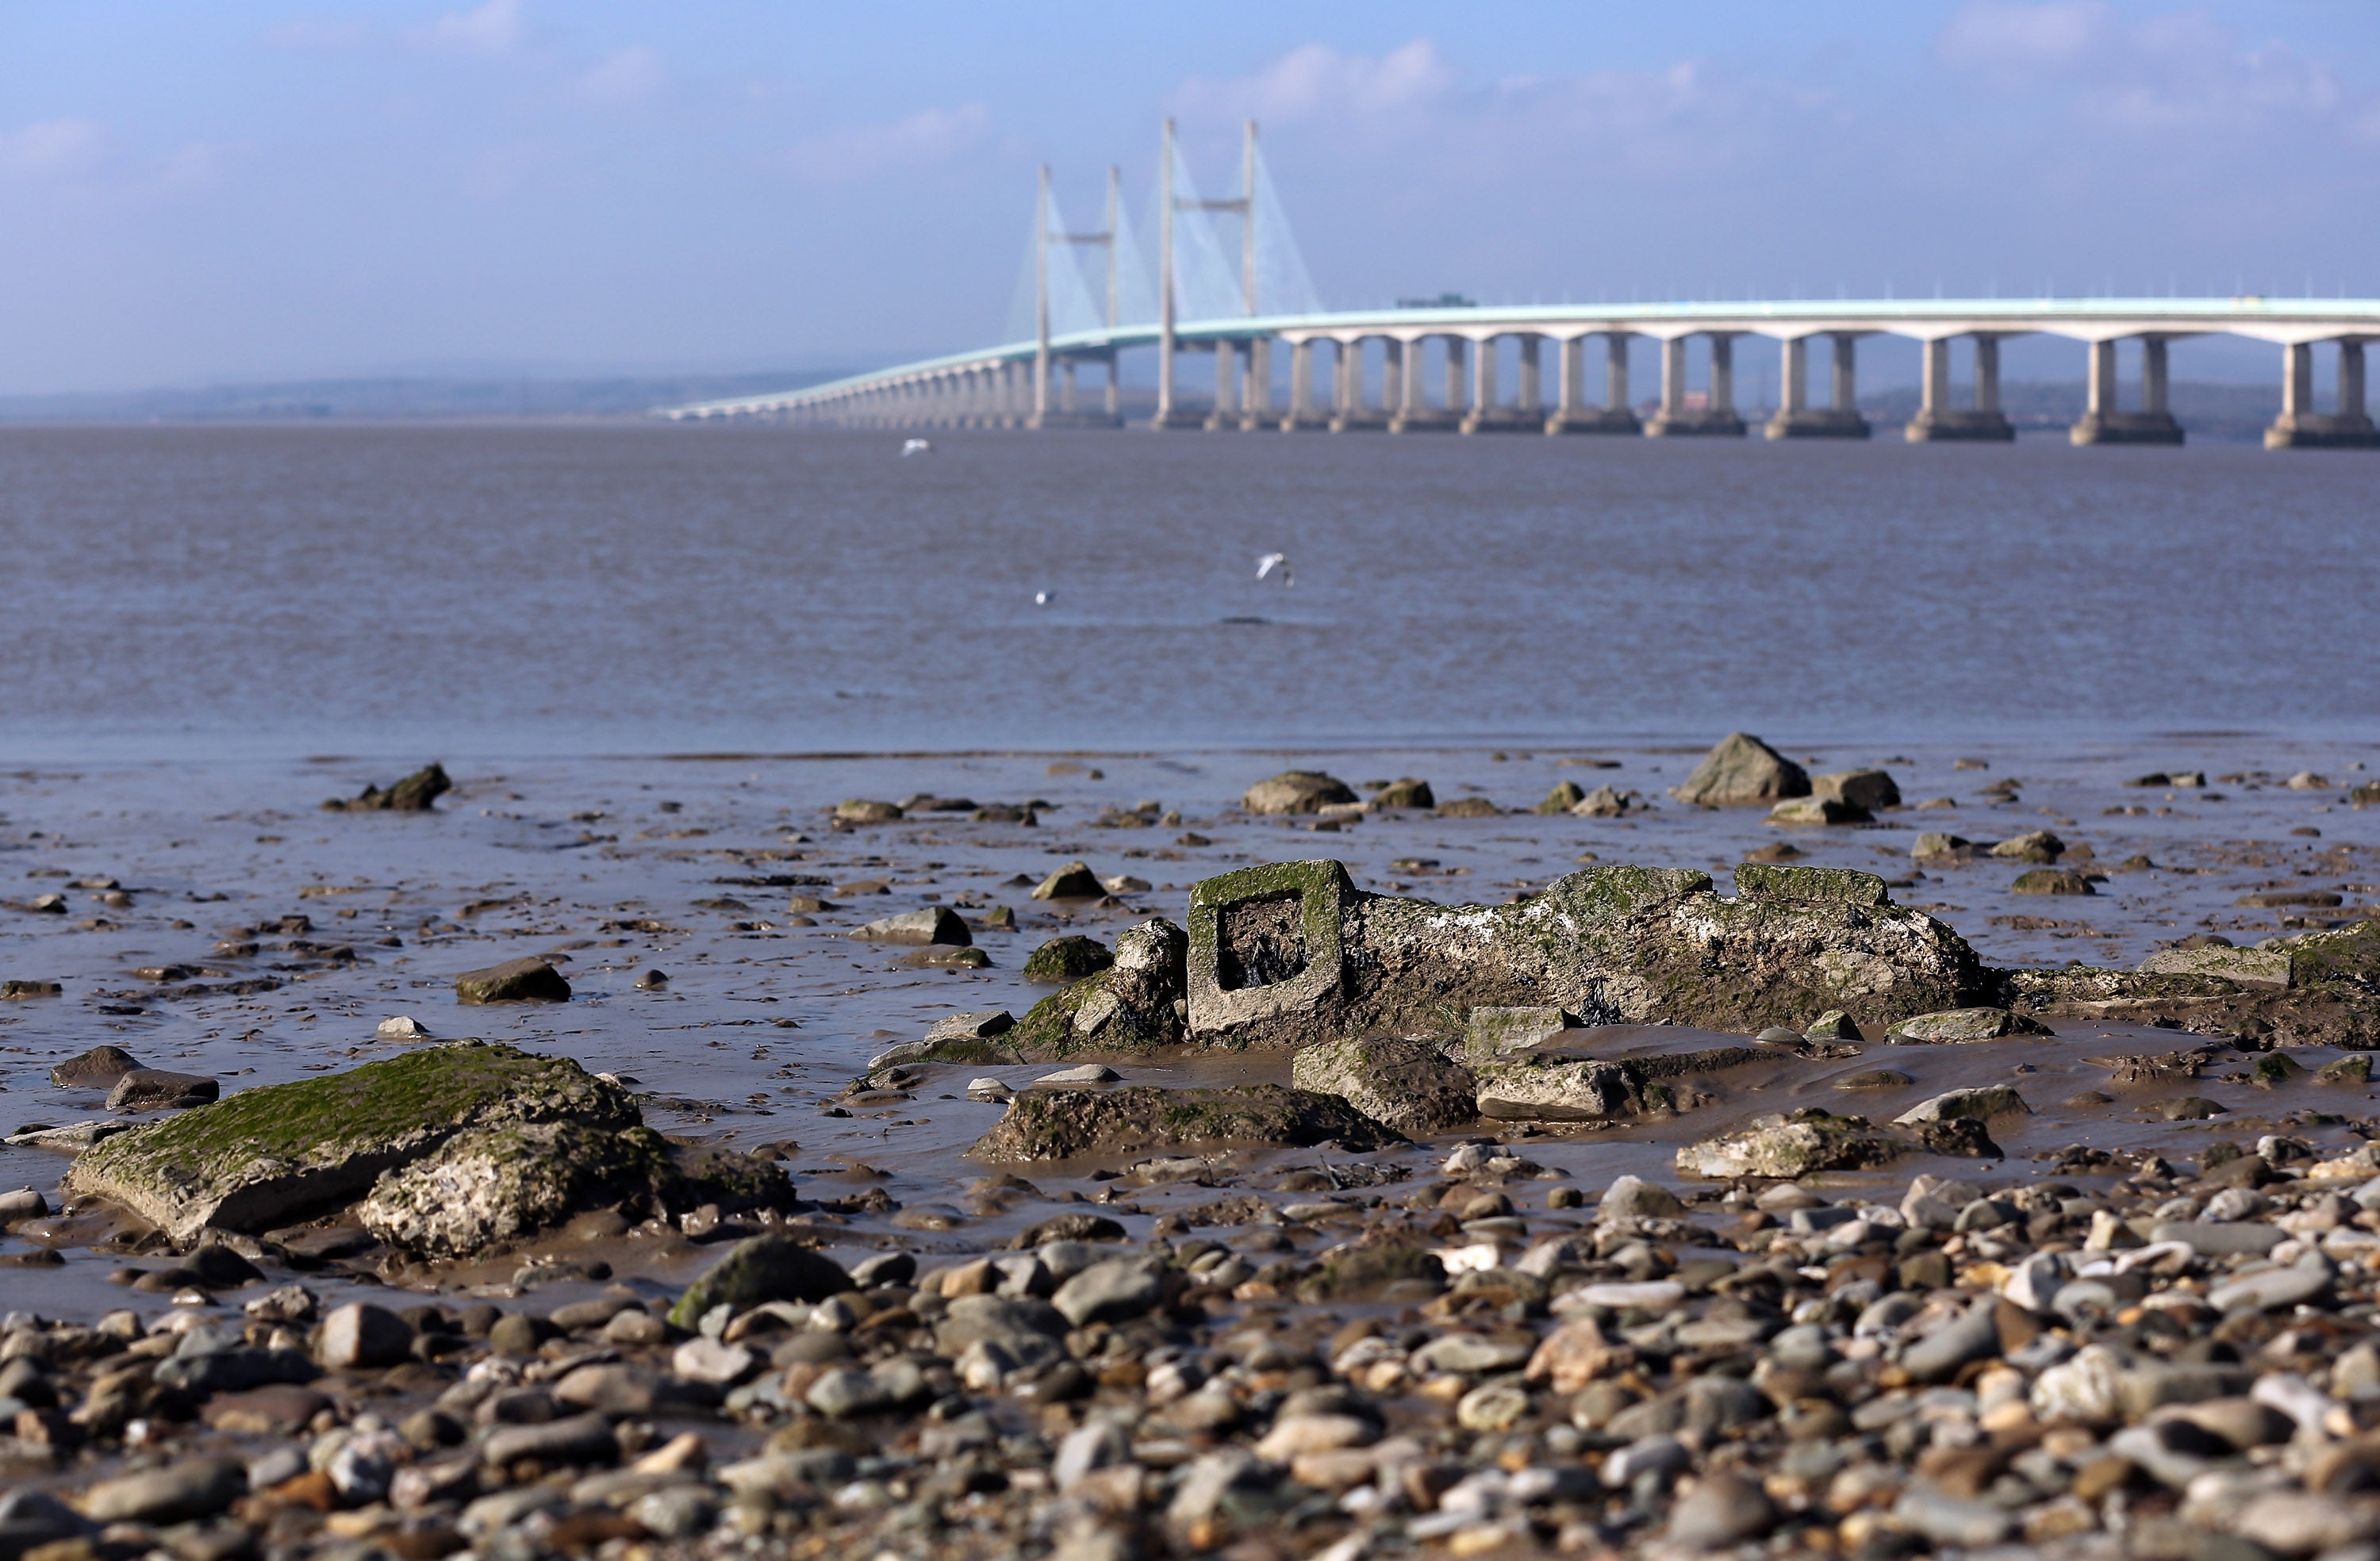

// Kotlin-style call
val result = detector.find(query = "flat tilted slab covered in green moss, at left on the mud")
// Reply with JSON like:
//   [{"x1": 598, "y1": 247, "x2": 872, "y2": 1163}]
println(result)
[{"x1": 62, "y1": 1042, "x2": 640, "y2": 1242}]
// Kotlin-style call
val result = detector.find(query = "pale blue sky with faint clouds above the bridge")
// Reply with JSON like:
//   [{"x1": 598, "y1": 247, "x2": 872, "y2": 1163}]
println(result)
[{"x1": 0, "y1": 0, "x2": 2380, "y2": 393}]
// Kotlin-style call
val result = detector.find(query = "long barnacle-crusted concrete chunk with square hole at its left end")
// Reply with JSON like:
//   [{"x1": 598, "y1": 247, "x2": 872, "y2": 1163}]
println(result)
[{"x1": 1180, "y1": 861, "x2": 1997, "y2": 1047}]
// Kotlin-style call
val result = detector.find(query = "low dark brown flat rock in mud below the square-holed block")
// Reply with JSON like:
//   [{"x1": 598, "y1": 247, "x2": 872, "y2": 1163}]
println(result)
[{"x1": 969, "y1": 1085, "x2": 1399, "y2": 1161}]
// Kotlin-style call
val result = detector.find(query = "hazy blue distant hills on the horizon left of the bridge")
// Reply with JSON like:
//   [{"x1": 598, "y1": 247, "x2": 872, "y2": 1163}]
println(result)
[{"x1": 0, "y1": 369, "x2": 845, "y2": 424}]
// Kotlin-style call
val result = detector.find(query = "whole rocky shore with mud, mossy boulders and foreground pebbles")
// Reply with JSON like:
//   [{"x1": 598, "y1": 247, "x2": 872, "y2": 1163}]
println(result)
[{"x1": 0, "y1": 735, "x2": 2380, "y2": 1561}]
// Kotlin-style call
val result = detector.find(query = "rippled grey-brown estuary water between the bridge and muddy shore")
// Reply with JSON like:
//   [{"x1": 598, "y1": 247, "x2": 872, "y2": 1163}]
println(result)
[{"x1": 0, "y1": 424, "x2": 2380, "y2": 759}]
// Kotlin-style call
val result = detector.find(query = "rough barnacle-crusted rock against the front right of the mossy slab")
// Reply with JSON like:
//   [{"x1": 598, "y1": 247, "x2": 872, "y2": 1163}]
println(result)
[{"x1": 355, "y1": 1121, "x2": 793, "y2": 1256}]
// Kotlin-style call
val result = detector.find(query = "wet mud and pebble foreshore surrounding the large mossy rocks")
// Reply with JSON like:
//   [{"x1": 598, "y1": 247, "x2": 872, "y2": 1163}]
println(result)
[{"x1": 0, "y1": 738, "x2": 2380, "y2": 1561}]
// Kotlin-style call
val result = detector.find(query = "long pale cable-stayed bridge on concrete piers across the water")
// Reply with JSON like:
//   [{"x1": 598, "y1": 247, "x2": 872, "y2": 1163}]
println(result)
[{"x1": 662, "y1": 119, "x2": 2380, "y2": 447}]
